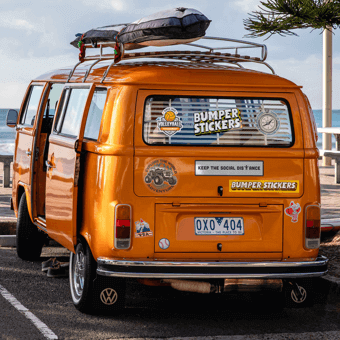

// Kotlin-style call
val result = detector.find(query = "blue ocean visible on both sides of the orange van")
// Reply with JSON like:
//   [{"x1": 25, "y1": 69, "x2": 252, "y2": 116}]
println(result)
[{"x1": 0, "y1": 109, "x2": 340, "y2": 155}]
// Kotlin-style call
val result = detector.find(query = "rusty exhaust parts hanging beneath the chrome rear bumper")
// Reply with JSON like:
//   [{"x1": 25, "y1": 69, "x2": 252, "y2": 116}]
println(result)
[{"x1": 161, "y1": 279, "x2": 283, "y2": 294}]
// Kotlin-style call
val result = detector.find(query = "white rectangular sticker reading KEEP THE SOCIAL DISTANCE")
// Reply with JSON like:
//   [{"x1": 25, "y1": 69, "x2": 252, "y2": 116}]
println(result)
[{"x1": 195, "y1": 161, "x2": 263, "y2": 176}]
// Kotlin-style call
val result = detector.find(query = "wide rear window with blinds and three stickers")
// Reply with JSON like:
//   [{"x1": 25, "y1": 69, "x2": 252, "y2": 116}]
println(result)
[{"x1": 143, "y1": 96, "x2": 294, "y2": 147}]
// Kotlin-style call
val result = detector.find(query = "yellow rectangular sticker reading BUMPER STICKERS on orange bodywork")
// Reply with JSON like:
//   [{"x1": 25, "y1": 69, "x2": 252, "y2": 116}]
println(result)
[{"x1": 229, "y1": 180, "x2": 300, "y2": 193}]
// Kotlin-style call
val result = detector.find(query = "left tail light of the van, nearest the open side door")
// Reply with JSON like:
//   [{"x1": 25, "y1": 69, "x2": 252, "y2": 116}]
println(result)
[{"x1": 114, "y1": 204, "x2": 131, "y2": 249}]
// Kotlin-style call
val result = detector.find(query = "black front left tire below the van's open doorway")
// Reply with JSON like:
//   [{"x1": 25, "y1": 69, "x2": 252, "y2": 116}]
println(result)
[{"x1": 16, "y1": 194, "x2": 47, "y2": 261}]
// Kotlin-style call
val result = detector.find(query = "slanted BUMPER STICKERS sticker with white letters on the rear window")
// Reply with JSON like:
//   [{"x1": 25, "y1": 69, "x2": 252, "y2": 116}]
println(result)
[{"x1": 194, "y1": 109, "x2": 242, "y2": 136}]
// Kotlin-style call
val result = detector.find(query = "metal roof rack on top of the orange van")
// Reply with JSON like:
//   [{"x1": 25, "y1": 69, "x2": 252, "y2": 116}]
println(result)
[{"x1": 67, "y1": 37, "x2": 275, "y2": 83}]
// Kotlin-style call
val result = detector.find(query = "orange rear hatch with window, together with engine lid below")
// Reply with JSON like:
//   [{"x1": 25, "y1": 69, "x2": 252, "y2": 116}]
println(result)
[{"x1": 134, "y1": 90, "x2": 304, "y2": 253}]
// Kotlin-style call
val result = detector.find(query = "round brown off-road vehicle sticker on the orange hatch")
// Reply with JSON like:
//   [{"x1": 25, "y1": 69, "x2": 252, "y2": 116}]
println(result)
[{"x1": 144, "y1": 159, "x2": 177, "y2": 193}]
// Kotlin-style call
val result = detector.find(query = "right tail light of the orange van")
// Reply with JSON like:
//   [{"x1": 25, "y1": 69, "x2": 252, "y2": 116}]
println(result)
[{"x1": 305, "y1": 205, "x2": 321, "y2": 249}]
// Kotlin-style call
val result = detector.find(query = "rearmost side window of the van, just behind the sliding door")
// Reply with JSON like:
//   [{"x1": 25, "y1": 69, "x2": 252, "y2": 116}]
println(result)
[{"x1": 84, "y1": 88, "x2": 107, "y2": 140}]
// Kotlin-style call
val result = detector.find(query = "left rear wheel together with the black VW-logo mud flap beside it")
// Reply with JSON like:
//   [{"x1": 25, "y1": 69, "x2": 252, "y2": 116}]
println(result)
[{"x1": 69, "y1": 241, "x2": 125, "y2": 314}]
